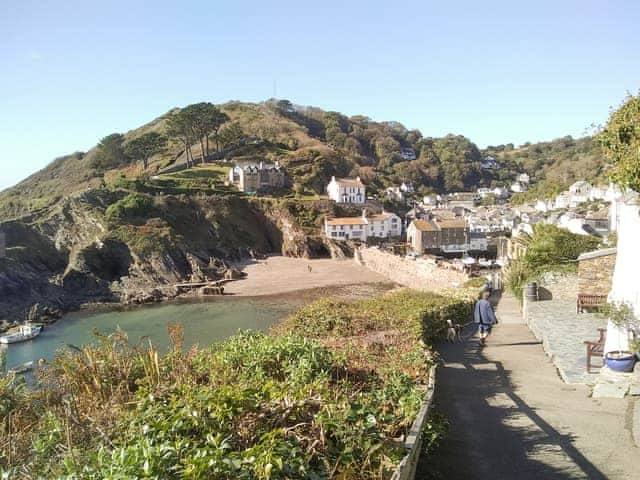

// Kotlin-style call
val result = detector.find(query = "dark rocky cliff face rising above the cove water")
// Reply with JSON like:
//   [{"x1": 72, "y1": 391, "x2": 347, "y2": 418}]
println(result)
[{"x1": 0, "y1": 190, "x2": 336, "y2": 319}]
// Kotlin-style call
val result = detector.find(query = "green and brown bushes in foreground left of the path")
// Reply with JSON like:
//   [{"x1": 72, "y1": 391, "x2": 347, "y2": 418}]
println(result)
[{"x1": 0, "y1": 291, "x2": 471, "y2": 480}]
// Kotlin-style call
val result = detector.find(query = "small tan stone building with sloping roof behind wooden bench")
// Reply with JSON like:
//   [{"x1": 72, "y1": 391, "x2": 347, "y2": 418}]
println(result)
[{"x1": 578, "y1": 248, "x2": 617, "y2": 295}]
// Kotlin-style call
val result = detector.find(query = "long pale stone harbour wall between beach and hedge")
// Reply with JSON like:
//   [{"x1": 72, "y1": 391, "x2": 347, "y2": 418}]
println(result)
[{"x1": 355, "y1": 248, "x2": 467, "y2": 292}]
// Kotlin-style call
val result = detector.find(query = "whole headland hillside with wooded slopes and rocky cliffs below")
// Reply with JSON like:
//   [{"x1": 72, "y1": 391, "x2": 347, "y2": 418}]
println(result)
[{"x1": 0, "y1": 101, "x2": 604, "y2": 318}]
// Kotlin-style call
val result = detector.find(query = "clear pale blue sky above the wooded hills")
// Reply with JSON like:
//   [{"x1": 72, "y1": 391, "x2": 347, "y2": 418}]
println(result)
[{"x1": 0, "y1": 0, "x2": 640, "y2": 189}]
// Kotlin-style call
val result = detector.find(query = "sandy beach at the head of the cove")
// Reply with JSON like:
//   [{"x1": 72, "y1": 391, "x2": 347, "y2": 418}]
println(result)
[{"x1": 225, "y1": 256, "x2": 391, "y2": 296}]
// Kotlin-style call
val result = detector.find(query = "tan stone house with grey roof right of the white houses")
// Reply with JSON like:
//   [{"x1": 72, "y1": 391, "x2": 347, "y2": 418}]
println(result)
[{"x1": 407, "y1": 219, "x2": 469, "y2": 253}]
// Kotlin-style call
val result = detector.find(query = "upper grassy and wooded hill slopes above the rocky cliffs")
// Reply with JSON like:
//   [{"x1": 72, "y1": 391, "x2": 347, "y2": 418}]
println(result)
[{"x1": 0, "y1": 100, "x2": 605, "y2": 220}]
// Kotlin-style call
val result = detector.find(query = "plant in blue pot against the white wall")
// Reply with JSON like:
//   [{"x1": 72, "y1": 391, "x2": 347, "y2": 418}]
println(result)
[{"x1": 601, "y1": 302, "x2": 638, "y2": 372}]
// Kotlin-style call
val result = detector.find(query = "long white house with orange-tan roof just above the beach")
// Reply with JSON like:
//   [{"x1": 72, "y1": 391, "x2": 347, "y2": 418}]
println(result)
[{"x1": 324, "y1": 210, "x2": 402, "y2": 242}]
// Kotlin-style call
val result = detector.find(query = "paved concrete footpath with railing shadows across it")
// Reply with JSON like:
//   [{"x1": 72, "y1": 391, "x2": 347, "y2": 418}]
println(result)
[{"x1": 416, "y1": 294, "x2": 640, "y2": 480}]
